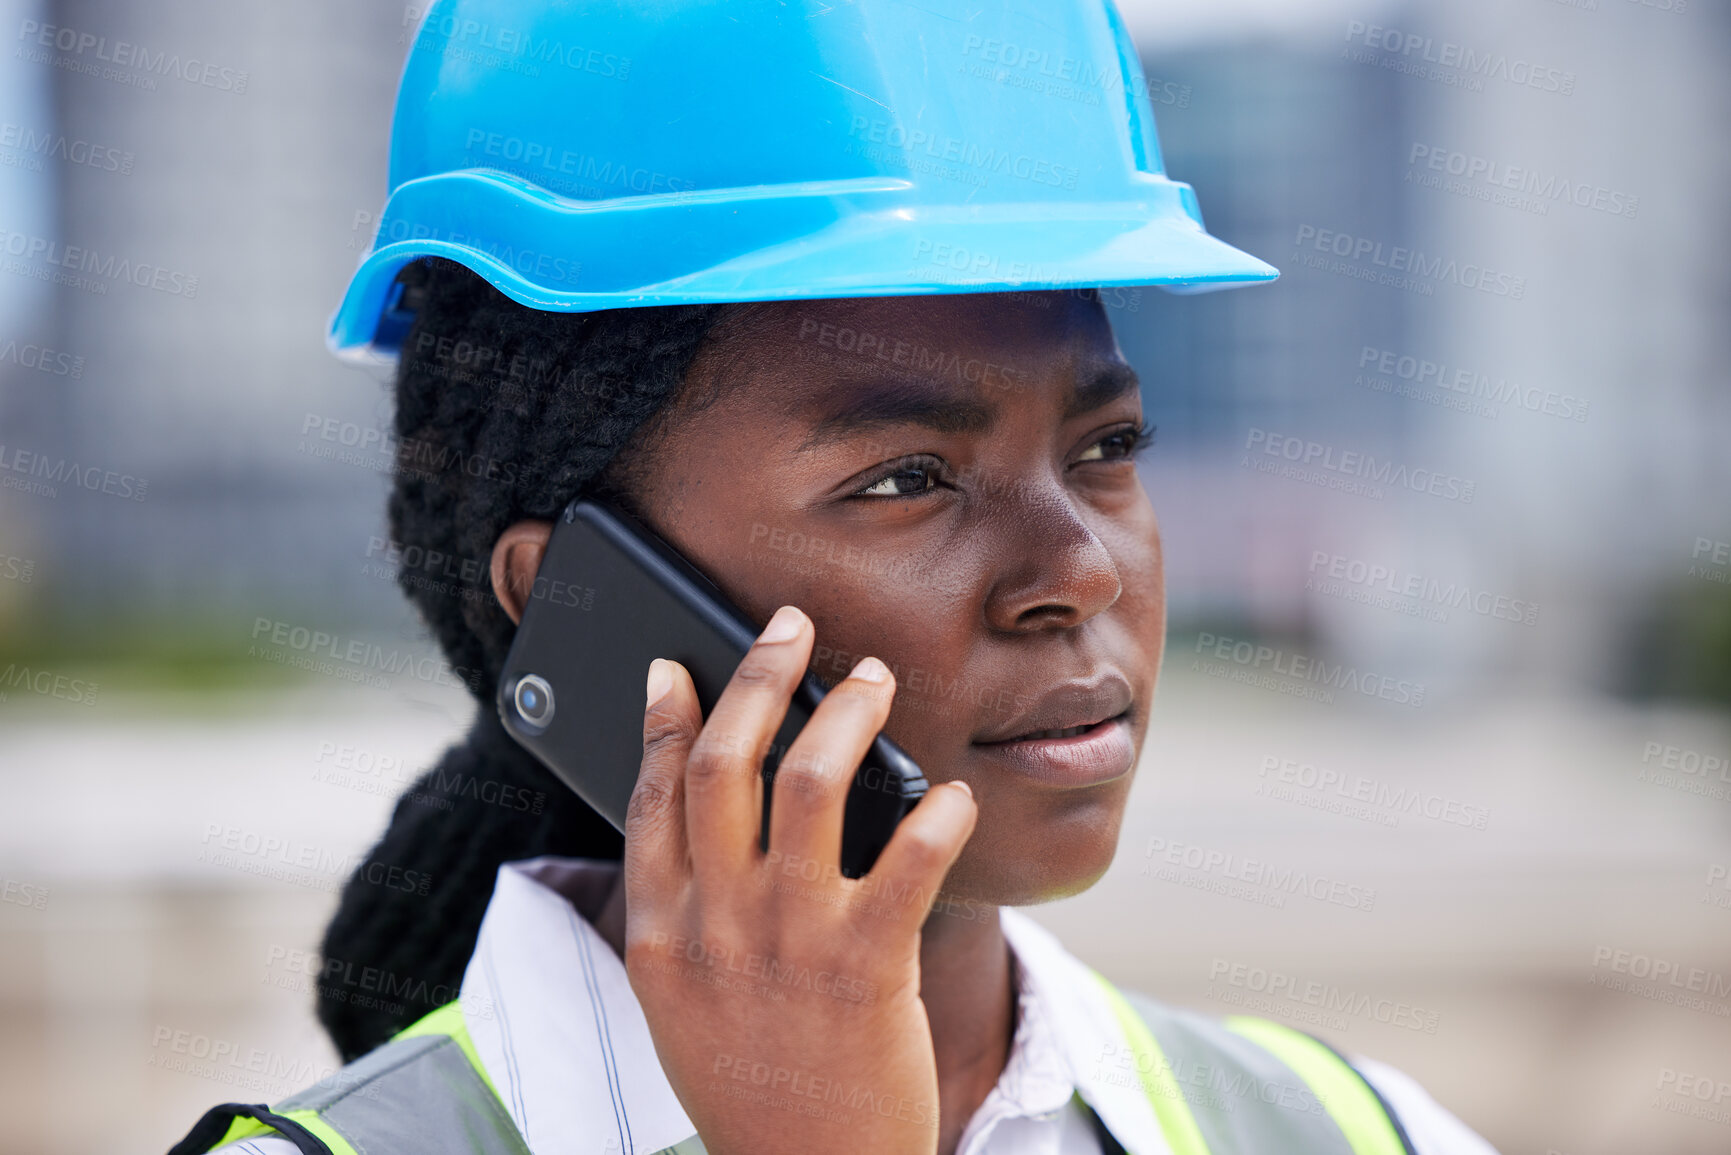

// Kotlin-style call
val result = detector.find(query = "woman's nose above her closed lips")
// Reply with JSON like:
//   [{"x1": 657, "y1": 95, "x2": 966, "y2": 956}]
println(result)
[{"x1": 985, "y1": 487, "x2": 1123, "y2": 634}]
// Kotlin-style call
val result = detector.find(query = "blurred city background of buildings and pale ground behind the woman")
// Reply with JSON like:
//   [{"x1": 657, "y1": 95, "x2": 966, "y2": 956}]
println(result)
[{"x1": 0, "y1": 0, "x2": 1731, "y2": 1155}]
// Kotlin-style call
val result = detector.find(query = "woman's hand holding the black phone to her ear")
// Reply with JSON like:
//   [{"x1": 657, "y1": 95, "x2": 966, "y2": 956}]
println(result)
[{"x1": 625, "y1": 606, "x2": 976, "y2": 1155}]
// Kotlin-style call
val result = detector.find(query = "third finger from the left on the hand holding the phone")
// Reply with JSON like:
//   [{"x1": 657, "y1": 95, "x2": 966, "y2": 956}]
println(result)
[{"x1": 769, "y1": 658, "x2": 895, "y2": 878}]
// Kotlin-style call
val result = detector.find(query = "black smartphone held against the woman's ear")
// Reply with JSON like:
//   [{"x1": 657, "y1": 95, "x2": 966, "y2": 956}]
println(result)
[{"x1": 497, "y1": 497, "x2": 926, "y2": 878}]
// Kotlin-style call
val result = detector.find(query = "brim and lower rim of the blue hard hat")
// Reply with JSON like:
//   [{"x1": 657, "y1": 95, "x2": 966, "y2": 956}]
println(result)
[{"x1": 327, "y1": 170, "x2": 1279, "y2": 362}]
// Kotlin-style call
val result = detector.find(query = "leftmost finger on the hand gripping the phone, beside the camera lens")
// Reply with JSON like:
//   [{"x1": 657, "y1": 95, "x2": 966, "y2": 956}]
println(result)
[{"x1": 625, "y1": 658, "x2": 703, "y2": 909}]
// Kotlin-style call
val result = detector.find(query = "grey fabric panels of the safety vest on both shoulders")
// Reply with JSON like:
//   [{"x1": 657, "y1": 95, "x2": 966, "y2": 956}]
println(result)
[{"x1": 240, "y1": 990, "x2": 1391, "y2": 1155}]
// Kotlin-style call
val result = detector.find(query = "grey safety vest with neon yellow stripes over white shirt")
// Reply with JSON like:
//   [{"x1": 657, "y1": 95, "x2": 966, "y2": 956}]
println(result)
[{"x1": 168, "y1": 971, "x2": 1414, "y2": 1155}]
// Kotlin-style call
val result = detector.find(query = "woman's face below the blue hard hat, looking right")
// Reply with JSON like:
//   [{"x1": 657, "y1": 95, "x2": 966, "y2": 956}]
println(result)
[{"x1": 609, "y1": 293, "x2": 1165, "y2": 906}]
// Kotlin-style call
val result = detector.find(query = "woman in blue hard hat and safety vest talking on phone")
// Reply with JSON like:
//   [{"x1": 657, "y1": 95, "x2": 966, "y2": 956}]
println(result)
[{"x1": 177, "y1": 3, "x2": 1489, "y2": 1155}]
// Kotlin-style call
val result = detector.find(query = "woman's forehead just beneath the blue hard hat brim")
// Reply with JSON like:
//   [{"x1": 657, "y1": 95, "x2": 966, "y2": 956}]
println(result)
[{"x1": 688, "y1": 293, "x2": 1136, "y2": 436}]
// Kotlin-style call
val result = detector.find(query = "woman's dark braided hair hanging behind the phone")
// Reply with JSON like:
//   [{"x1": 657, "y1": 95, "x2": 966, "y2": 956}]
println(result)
[{"x1": 319, "y1": 258, "x2": 736, "y2": 1061}]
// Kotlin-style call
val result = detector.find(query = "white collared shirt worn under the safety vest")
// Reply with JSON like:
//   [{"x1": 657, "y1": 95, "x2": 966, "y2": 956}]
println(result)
[{"x1": 220, "y1": 857, "x2": 1496, "y2": 1155}]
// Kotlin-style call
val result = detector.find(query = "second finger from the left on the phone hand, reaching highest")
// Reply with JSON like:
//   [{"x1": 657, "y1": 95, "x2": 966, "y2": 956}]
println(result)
[{"x1": 685, "y1": 606, "x2": 814, "y2": 878}]
